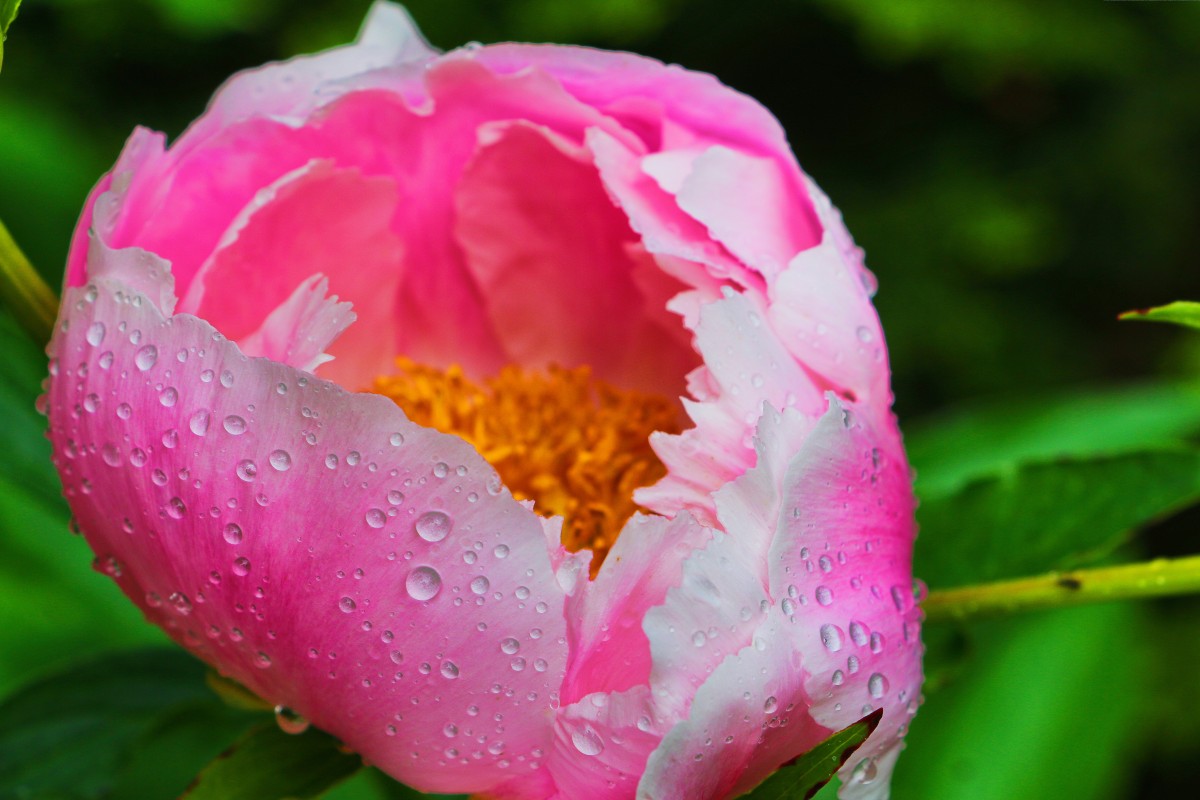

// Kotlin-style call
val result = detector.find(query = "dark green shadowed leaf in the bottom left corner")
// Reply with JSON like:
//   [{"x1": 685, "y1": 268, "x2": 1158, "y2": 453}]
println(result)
[{"x1": 0, "y1": 649, "x2": 263, "y2": 800}]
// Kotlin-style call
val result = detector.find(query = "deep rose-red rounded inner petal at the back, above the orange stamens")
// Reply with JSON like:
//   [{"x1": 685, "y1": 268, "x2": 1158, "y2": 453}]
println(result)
[{"x1": 455, "y1": 122, "x2": 696, "y2": 395}]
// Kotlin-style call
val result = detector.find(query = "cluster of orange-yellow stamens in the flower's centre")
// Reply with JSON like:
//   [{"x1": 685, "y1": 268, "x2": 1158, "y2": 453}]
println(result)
[{"x1": 372, "y1": 357, "x2": 680, "y2": 572}]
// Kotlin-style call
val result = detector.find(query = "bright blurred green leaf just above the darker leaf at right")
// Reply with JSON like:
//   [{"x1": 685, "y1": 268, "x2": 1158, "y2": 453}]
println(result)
[{"x1": 905, "y1": 384, "x2": 1200, "y2": 503}]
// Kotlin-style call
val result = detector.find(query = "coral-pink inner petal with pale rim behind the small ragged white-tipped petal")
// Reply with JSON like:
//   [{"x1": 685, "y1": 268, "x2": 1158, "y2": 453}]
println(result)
[{"x1": 181, "y1": 161, "x2": 403, "y2": 389}]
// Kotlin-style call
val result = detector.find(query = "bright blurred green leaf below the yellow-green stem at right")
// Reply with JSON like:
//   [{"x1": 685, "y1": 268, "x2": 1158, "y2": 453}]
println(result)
[{"x1": 892, "y1": 603, "x2": 1142, "y2": 800}]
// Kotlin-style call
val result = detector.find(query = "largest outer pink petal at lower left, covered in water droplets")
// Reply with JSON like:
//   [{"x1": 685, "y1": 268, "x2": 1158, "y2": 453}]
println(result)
[{"x1": 48, "y1": 277, "x2": 568, "y2": 792}]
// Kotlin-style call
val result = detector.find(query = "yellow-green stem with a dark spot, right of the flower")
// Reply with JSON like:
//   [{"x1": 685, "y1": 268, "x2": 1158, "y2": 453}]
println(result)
[{"x1": 922, "y1": 555, "x2": 1200, "y2": 620}]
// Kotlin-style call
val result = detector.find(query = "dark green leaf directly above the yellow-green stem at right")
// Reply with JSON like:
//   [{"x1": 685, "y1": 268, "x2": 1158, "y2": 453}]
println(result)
[{"x1": 913, "y1": 449, "x2": 1200, "y2": 589}]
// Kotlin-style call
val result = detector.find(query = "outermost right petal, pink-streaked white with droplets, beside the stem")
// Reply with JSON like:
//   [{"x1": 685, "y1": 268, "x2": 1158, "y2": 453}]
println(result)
[{"x1": 767, "y1": 401, "x2": 922, "y2": 800}]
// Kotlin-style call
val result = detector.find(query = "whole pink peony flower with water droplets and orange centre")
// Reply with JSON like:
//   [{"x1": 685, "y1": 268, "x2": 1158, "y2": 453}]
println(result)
[{"x1": 39, "y1": 5, "x2": 922, "y2": 799}]
